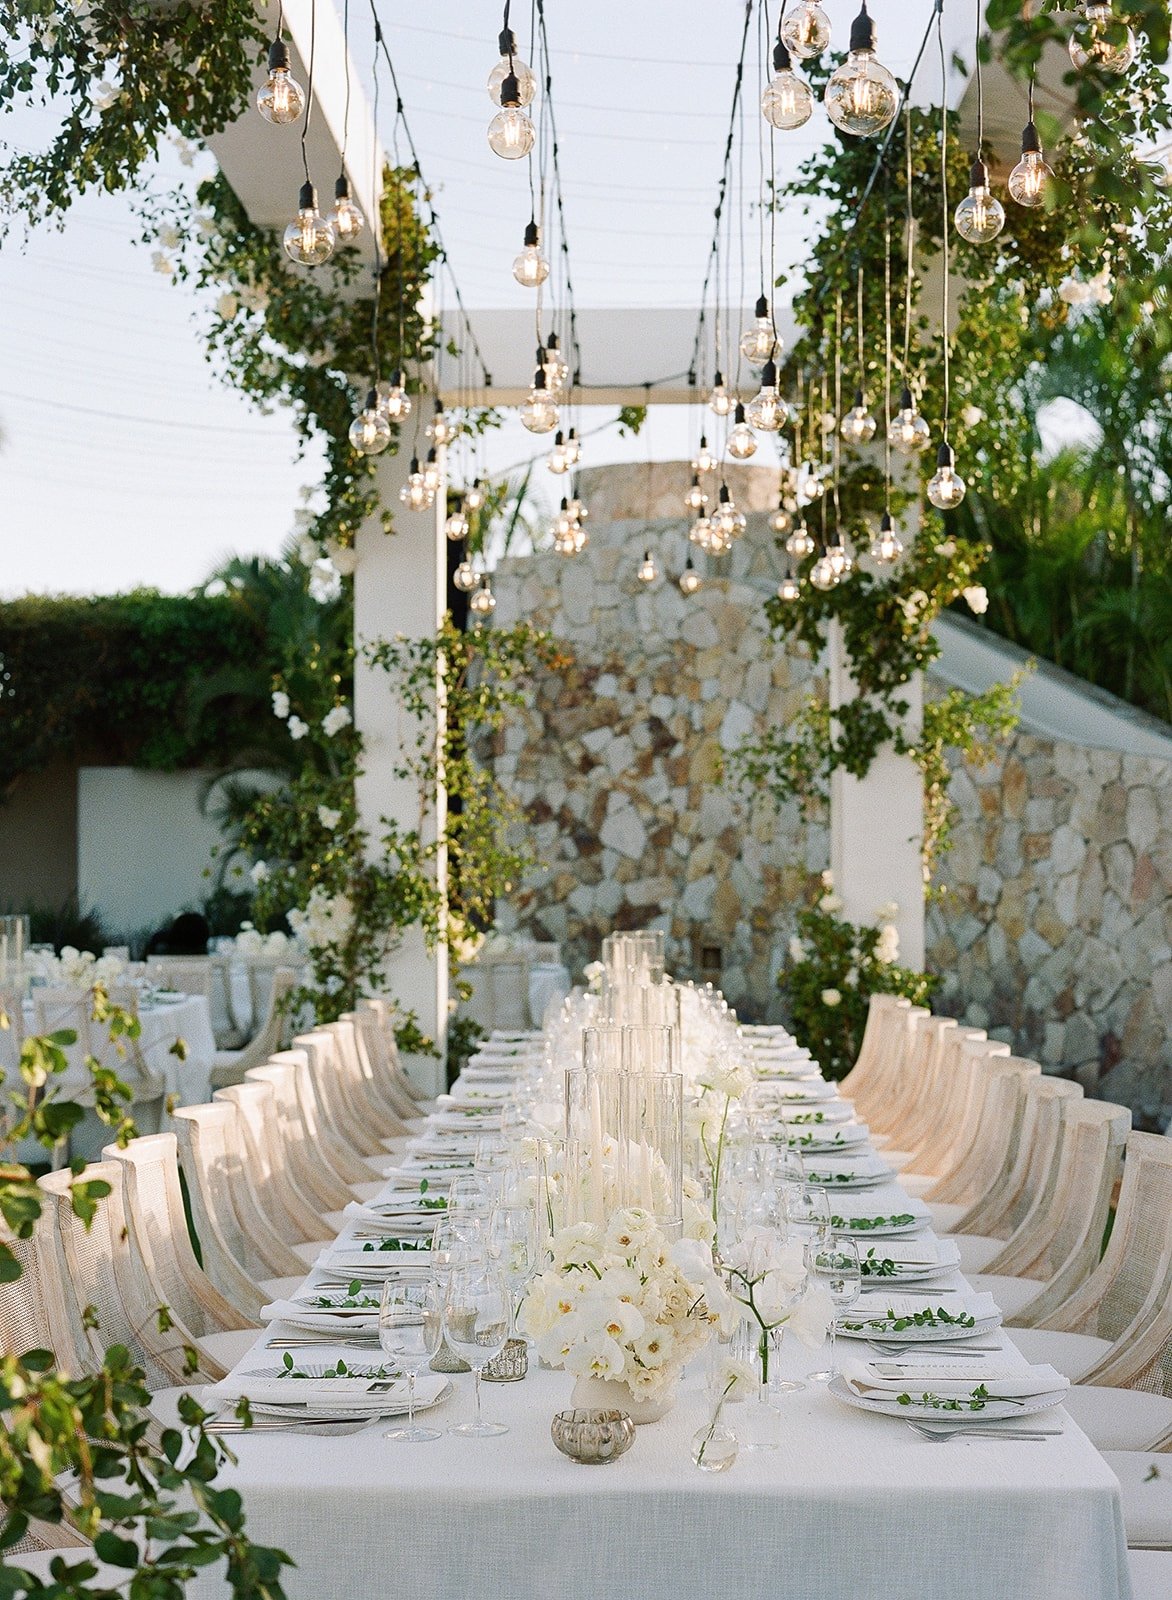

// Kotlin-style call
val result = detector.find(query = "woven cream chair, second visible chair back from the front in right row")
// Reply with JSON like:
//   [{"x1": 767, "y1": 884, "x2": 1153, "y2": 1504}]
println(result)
[{"x1": 972, "y1": 1101, "x2": 1132, "y2": 1326}]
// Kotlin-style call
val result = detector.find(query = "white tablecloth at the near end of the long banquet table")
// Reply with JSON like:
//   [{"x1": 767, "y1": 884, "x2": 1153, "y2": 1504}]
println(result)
[{"x1": 178, "y1": 1030, "x2": 1130, "y2": 1600}]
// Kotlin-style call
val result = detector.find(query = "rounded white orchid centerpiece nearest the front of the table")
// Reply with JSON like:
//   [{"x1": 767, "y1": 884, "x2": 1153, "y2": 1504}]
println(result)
[{"x1": 519, "y1": 1206, "x2": 735, "y2": 1422}]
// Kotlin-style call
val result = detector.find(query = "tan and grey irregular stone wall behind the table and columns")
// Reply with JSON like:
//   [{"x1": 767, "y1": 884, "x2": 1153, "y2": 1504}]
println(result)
[{"x1": 495, "y1": 462, "x2": 1172, "y2": 1123}]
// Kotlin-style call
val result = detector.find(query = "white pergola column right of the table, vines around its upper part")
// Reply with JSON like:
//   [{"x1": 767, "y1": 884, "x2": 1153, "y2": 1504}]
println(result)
[{"x1": 828, "y1": 622, "x2": 924, "y2": 968}]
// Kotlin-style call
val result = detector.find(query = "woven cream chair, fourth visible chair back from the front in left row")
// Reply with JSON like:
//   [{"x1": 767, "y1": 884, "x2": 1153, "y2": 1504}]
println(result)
[{"x1": 175, "y1": 1102, "x2": 306, "y2": 1322}]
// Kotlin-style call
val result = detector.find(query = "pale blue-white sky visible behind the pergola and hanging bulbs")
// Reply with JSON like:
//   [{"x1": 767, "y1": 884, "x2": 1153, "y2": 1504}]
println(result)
[{"x1": 0, "y1": 0, "x2": 1018, "y2": 597}]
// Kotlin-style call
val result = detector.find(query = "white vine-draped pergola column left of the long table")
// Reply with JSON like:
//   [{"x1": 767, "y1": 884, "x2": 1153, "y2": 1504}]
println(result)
[{"x1": 354, "y1": 438, "x2": 448, "y2": 1094}]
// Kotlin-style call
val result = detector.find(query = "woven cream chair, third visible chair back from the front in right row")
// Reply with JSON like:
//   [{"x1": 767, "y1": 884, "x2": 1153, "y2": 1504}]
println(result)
[{"x1": 949, "y1": 1075, "x2": 1082, "y2": 1274}]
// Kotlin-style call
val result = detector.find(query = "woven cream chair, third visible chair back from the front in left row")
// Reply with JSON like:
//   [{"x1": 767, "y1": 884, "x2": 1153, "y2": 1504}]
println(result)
[{"x1": 102, "y1": 1133, "x2": 256, "y2": 1378}]
